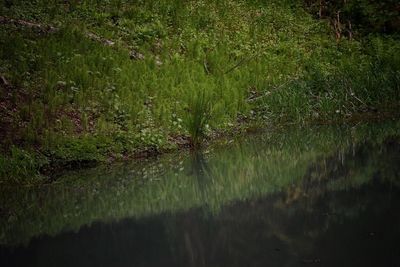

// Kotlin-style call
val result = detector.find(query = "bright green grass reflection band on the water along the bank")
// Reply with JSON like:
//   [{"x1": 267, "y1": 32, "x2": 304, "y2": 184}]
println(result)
[{"x1": 0, "y1": 123, "x2": 399, "y2": 247}]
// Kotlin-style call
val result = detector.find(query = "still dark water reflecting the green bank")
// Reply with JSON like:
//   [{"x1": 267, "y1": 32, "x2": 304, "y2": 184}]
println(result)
[{"x1": 0, "y1": 122, "x2": 400, "y2": 267}]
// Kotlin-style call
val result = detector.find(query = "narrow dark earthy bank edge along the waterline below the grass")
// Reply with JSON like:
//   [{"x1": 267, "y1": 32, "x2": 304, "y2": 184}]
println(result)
[{"x1": 0, "y1": 109, "x2": 400, "y2": 186}]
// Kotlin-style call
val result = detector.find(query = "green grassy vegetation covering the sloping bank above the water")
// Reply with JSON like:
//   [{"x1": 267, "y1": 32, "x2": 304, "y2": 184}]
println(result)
[{"x1": 0, "y1": 0, "x2": 400, "y2": 184}]
